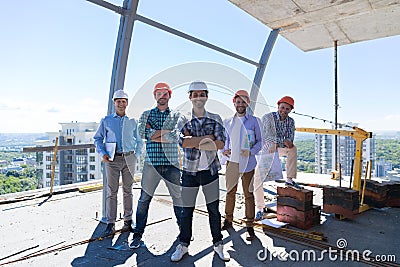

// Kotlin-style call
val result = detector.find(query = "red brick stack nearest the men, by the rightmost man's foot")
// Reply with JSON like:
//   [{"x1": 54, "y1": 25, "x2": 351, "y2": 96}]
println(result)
[{"x1": 276, "y1": 187, "x2": 321, "y2": 230}]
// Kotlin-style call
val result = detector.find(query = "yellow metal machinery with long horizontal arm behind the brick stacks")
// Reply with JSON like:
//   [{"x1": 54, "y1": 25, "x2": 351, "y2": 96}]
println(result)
[{"x1": 296, "y1": 127, "x2": 372, "y2": 212}]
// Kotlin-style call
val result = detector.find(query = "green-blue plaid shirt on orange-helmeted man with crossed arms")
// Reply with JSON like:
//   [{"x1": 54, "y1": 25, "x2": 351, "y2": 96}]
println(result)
[{"x1": 138, "y1": 107, "x2": 179, "y2": 167}]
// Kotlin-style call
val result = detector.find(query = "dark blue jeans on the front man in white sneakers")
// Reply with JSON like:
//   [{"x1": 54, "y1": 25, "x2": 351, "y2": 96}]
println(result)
[{"x1": 179, "y1": 170, "x2": 222, "y2": 246}]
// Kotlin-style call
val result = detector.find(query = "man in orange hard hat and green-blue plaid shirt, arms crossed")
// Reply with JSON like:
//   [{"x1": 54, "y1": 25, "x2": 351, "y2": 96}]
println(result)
[{"x1": 130, "y1": 82, "x2": 182, "y2": 248}]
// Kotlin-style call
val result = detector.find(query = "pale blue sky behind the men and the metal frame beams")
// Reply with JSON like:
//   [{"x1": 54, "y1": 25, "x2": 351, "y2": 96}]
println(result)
[{"x1": 0, "y1": 0, "x2": 400, "y2": 133}]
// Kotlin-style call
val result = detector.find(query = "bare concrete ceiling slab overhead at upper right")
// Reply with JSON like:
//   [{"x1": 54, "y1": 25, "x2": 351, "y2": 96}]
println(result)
[{"x1": 229, "y1": 0, "x2": 400, "y2": 51}]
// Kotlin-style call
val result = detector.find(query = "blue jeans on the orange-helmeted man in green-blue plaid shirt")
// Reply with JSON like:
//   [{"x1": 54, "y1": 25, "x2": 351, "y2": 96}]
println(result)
[{"x1": 133, "y1": 163, "x2": 182, "y2": 234}]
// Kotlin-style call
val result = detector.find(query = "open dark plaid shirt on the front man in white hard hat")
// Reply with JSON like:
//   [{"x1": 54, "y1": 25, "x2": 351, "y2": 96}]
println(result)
[{"x1": 178, "y1": 111, "x2": 226, "y2": 175}]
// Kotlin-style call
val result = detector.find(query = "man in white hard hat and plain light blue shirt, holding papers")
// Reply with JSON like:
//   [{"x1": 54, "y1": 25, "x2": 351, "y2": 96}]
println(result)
[{"x1": 94, "y1": 90, "x2": 143, "y2": 235}]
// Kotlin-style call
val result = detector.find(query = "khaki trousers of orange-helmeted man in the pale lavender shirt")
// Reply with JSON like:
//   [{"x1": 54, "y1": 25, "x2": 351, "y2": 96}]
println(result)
[{"x1": 225, "y1": 161, "x2": 255, "y2": 227}]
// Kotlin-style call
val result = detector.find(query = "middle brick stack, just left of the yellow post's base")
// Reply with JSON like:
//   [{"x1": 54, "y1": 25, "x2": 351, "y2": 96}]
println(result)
[{"x1": 322, "y1": 186, "x2": 360, "y2": 218}]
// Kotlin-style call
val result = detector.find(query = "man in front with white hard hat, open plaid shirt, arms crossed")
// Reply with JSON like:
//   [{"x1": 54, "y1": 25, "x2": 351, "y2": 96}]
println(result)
[{"x1": 171, "y1": 81, "x2": 230, "y2": 261}]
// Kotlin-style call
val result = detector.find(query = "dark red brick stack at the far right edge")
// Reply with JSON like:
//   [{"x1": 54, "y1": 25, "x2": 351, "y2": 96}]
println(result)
[{"x1": 361, "y1": 180, "x2": 400, "y2": 208}]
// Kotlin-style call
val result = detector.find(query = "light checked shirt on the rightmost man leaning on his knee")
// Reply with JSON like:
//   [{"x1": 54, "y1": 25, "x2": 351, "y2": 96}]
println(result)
[{"x1": 262, "y1": 112, "x2": 295, "y2": 151}]
